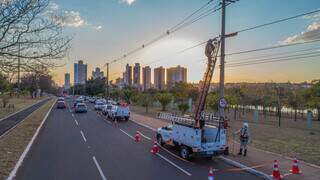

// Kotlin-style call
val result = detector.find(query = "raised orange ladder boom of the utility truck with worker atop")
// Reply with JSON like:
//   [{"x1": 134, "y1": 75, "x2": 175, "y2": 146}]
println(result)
[{"x1": 194, "y1": 38, "x2": 220, "y2": 129}]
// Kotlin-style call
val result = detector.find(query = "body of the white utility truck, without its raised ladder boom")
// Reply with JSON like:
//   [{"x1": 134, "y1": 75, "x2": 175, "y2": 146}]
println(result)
[{"x1": 156, "y1": 122, "x2": 227, "y2": 159}]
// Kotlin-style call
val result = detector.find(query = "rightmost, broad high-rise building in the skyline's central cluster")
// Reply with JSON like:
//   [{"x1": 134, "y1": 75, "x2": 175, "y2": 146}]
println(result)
[{"x1": 167, "y1": 66, "x2": 187, "y2": 88}]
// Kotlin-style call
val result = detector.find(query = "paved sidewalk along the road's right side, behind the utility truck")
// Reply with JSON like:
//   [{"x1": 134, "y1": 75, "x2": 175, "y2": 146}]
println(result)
[{"x1": 131, "y1": 112, "x2": 320, "y2": 180}]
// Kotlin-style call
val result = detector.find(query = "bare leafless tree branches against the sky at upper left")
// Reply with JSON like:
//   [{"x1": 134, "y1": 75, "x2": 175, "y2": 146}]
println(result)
[{"x1": 0, "y1": 0, "x2": 71, "y2": 74}]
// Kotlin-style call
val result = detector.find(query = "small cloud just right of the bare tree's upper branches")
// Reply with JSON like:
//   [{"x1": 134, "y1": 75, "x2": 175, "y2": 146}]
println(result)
[{"x1": 52, "y1": 11, "x2": 87, "y2": 28}]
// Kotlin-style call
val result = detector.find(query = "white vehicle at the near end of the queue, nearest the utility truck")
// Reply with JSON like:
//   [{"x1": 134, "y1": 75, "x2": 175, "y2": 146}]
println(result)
[{"x1": 107, "y1": 105, "x2": 130, "y2": 121}]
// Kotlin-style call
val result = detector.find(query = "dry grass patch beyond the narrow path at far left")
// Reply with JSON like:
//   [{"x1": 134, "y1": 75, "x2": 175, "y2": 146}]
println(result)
[{"x1": 0, "y1": 97, "x2": 42, "y2": 119}]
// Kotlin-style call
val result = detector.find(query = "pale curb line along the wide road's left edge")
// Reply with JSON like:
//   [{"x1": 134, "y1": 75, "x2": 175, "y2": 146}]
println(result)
[{"x1": 7, "y1": 100, "x2": 57, "y2": 180}]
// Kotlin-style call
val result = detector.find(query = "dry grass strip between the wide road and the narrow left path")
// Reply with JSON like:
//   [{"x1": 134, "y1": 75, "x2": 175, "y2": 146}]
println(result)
[{"x1": 0, "y1": 99, "x2": 54, "y2": 179}]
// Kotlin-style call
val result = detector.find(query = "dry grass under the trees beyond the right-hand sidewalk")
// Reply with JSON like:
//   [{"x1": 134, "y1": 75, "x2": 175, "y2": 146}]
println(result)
[{"x1": 131, "y1": 106, "x2": 320, "y2": 165}]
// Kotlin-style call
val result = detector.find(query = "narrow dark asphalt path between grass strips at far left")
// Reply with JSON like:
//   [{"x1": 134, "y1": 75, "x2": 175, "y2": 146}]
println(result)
[{"x1": 0, "y1": 99, "x2": 49, "y2": 136}]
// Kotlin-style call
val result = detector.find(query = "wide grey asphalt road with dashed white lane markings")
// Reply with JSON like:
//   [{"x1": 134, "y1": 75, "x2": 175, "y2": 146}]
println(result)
[{"x1": 16, "y1": 100, "x2": 259, "y2": 180}]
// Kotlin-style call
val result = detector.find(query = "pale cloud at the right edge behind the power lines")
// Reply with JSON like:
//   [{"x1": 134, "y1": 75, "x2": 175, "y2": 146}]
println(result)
[{"x1": 280, "y1": 22, "x2": 320, "y2": 44}]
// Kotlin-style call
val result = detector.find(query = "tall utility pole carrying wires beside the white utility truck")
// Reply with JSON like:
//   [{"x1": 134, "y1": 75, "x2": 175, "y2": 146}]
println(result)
[{"x1": 219, "y1": 0, "x2": 226, "y2": 119}]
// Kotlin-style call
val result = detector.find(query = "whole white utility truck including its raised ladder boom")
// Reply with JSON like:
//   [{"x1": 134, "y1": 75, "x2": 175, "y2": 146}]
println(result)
[{"x1": 157, "y1": 38, "x2": 228, "y2": 159}]
